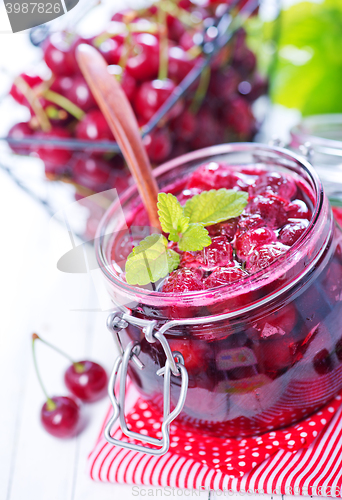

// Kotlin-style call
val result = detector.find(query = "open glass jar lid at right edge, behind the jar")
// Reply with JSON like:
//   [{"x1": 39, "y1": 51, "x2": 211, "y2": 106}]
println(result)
[{"x1": 290, "y1": 113, "x2": 342, "y2": 205}]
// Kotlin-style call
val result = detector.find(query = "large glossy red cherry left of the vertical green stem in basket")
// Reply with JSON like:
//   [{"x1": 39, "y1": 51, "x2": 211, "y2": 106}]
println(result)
[{"x1": 126, "y1": 33, "x2": 159, "y2": 81}]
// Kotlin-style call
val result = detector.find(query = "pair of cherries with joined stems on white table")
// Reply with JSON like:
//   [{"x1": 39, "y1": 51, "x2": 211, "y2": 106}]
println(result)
[{"x1": 32, "y1": 333, "x2": 108, "y2": 438}]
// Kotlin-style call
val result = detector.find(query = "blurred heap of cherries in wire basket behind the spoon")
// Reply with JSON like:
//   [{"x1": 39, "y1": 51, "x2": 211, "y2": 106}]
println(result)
[{"x1": 9, "y1": 0, "x2": 267, "y2": 199}]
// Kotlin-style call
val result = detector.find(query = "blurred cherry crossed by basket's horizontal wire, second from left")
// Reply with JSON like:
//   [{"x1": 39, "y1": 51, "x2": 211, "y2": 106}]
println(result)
[{"x1": 34, "y1": 127, "x2": 72, "y2": 169}]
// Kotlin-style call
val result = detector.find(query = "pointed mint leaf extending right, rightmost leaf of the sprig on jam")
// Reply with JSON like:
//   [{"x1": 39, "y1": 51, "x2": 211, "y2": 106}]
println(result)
[{"x1": 184, "y1": 188, "x2": 248, "y2": 226}]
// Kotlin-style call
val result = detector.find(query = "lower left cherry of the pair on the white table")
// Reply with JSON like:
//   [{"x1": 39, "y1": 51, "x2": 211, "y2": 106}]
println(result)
[{"x1": 40, "y1": 396, "x2": 80, "y2": 438}]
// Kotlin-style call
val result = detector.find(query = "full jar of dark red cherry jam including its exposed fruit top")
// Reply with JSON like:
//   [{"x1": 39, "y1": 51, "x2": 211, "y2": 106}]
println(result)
[{"x1": 96, "y1": 143, "x2": 342, "y2": 437}]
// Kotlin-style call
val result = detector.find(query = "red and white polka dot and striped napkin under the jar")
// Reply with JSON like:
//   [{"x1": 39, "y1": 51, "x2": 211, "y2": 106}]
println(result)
[{"x1": 88, "y1": 384, "x2": 342, "y2": 496}]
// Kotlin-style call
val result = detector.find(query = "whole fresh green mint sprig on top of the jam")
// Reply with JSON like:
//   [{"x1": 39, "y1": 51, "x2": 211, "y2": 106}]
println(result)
[{"x1": 125, "y1": 188, "x2": 248, "y2": 285}]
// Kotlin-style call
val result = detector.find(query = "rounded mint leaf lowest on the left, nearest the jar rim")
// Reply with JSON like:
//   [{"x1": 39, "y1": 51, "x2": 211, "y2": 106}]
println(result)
[{"x1": 125, "y1": 234, "x2": 180, "y2": 285}]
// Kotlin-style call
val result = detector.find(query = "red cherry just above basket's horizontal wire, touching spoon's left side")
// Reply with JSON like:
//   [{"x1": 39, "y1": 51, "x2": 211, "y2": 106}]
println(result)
[{"x1": 76, "y1": 109, "x2": 114, "y2": 141}]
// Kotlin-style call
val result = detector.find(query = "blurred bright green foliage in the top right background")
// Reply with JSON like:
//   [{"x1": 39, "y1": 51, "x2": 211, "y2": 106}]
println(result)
[{"x1": 264, "y1": 0, "x2": 342, "y2": 115}]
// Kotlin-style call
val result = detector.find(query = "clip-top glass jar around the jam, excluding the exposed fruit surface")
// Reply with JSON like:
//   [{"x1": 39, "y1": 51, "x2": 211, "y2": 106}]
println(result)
[{"x1": 96, "y1": 143, "x2": 342, "y2": 437}]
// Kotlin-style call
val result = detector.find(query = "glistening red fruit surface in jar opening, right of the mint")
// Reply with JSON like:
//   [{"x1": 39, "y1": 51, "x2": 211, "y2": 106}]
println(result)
[{"x1": 162, "y1": 162, "x2": 311, "y2": 292}]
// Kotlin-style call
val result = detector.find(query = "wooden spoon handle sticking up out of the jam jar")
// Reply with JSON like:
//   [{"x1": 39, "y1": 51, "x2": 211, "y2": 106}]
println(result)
[{"x1": 76, "y1": 44, "x2": 160, "y2": 229}]
